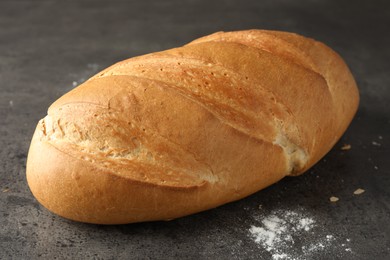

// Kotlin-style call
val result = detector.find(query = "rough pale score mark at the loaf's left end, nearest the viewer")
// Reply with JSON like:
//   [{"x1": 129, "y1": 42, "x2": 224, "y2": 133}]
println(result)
[{"x1": 38, "y1": 103, "x2": 218, "y2": 187}]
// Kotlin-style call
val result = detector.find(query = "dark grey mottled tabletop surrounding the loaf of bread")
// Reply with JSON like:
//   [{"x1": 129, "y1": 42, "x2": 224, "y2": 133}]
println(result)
[{"x1": 0, "y1": 0, "x2": 390, "y2": 259}]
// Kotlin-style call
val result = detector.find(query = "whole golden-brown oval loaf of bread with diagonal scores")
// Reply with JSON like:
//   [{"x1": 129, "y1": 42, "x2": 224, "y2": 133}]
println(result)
[{"x1": 27, "y1": 30, "x2": 359, "y2": 224}]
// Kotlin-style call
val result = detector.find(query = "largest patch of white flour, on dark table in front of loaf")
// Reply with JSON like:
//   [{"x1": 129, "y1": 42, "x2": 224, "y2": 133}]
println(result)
[{"x1": 249, "y1": 209, "x2": 352, "y2": 260}]
